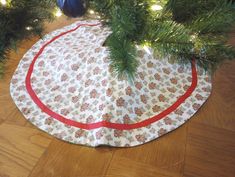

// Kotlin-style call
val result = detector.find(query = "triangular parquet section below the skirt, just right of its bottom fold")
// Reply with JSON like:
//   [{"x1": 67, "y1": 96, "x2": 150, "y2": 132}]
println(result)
[{"x1": 114, "y1": 125, "x2": 187, "y2": 173}]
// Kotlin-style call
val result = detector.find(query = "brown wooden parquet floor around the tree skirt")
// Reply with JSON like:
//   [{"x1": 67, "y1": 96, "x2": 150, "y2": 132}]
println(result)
[{"x1": 0, "y1": 18, "x2": 235, "y2": 177}]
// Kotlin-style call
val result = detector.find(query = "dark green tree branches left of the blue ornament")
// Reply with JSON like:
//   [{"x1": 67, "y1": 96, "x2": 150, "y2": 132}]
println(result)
[{"x1": 0, "y1": 0, "x2": 56, "y2": 76}]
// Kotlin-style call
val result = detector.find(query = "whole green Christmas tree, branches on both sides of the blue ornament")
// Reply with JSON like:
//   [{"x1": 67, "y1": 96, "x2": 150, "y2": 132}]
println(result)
[{"x1": 0, "y1": 0, "x2": 235, "y2": 80}]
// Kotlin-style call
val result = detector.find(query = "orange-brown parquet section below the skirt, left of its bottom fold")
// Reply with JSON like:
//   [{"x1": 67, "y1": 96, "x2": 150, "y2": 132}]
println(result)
[{"x1": 29, "y1": 140, "x2": 115, "y2": 177}]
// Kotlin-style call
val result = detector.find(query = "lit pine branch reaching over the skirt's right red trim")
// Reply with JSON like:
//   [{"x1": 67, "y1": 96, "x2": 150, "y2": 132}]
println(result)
[{"x1": 148, "y1": 17, "x2": 235, "y2": 70}]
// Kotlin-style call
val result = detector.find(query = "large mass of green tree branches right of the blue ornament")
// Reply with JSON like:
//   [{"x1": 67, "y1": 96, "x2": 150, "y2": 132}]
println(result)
[{"x1": 87, "y1": 0, "x2": 235, "y2": 78}]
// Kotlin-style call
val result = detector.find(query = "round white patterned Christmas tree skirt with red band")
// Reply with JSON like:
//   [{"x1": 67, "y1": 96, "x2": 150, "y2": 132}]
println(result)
[{"x1": 10, "y1": 21, "x2": 211, "y2": 147}]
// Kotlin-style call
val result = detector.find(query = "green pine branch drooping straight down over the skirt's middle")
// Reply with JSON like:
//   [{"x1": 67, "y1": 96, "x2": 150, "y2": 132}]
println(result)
[{"x1": 90, "y1": 0, "x2": 149, "y2": 80}]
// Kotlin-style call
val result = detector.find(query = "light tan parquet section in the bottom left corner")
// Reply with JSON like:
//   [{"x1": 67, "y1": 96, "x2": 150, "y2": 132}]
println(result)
[{"x1": 0, "y1": 123, "x2": 51, "y2": 177}]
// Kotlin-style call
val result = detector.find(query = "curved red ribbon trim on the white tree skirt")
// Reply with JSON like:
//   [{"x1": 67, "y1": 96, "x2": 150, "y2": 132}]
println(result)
[{"x1": 25, "y1": 24, "x2": 198, "y2": 130}]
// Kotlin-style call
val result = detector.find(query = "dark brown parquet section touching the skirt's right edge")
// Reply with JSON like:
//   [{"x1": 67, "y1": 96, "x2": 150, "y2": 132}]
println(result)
[{"x1": 189, "y1": 58, "x2": 235, "y2": 131}]
